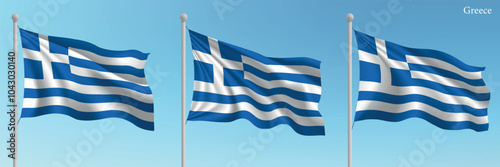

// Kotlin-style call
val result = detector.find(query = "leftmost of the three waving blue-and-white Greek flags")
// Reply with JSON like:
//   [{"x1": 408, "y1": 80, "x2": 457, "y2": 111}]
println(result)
[{"x1": 20, "y1": 29, "x2": 154, "y2": 130}]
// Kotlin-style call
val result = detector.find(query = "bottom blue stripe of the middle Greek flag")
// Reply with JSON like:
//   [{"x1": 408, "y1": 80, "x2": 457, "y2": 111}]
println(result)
[{"x1": 188, "y1": 111, "x2": 325, "y2": 136}]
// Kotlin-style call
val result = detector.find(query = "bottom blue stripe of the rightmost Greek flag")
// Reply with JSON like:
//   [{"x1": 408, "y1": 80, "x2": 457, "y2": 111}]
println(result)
[{"x1": 354, "y1": 110, "x2": 489, "y2": 132}]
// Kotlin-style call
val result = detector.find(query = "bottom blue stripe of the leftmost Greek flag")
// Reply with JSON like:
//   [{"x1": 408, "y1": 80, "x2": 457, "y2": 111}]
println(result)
[{"x1": 21, "y1": 105, "x2": 154, "y2": 131}]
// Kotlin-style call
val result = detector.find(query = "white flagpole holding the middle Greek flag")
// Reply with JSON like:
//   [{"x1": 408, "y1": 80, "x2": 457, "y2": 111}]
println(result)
[{"x1": 180, "y1": 13, "x2": 187, "y2": 167}]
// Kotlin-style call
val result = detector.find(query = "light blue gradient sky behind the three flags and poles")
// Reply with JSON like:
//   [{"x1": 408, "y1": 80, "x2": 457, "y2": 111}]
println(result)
[{"x1": 0, "y1": 0, "x2": 500, "y2": 167}]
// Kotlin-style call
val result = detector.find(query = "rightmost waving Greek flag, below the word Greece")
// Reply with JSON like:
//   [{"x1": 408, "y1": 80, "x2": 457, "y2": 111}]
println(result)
[{"x1": 355, "y1": 31, "x2": 490, "y2": 131}]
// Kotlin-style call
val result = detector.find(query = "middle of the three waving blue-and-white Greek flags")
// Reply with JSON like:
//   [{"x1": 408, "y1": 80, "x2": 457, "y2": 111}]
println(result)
[{"x1": 188, "y1": 30, "x2": 325, "y2": 135}]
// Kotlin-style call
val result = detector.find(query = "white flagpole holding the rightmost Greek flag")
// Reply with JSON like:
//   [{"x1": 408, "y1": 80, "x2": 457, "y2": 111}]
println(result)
[{"x1": 346, "y1": 13, "x2": 354, "y2": 167}]
